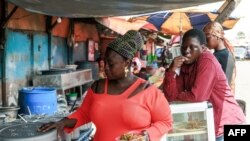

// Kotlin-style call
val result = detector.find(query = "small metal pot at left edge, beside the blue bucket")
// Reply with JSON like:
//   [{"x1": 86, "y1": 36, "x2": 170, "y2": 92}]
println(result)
[{"x1": 0, "y1": 107, "x2": 20, "y2": 122}]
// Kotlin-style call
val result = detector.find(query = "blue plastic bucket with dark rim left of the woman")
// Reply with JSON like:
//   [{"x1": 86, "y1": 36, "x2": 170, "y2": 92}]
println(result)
[{"x1": 19, "y1": 87, "x2": 57, "y2": 115}]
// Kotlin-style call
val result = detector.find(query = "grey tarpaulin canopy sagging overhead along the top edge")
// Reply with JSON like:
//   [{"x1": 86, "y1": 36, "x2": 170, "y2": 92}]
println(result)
[{"x1": 8, "y1": 0, "x2": 222, "y2": 17}]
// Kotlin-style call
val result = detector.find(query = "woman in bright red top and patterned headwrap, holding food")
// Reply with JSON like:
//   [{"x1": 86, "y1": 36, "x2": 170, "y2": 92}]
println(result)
[{"x1": 40, "y1": 31, "x2": 172, "y2": 141}]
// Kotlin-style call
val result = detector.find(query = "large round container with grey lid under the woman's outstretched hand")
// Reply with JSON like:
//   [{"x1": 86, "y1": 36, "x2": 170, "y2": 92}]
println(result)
[{"x1": 0, "y1": 123, "x2": 57, "y2": 141}]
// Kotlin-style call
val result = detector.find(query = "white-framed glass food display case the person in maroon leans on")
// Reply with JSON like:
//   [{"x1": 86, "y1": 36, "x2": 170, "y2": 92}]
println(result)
[{"x1": 161, "y1": 101, "x2": 215, "y2": 141}]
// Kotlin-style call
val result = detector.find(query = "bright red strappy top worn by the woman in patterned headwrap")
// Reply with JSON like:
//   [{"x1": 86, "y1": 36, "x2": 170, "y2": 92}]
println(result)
[{"x1": 65, "y1": 78, "x2": 172, "y2": 141}]
